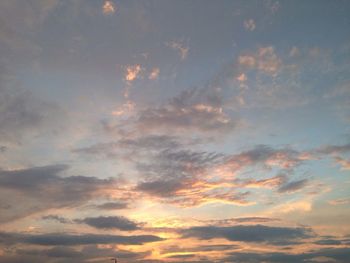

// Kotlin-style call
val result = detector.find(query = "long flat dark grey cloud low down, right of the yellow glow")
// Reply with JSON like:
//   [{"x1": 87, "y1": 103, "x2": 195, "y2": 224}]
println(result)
[{"x1": 180, "y1": 225, "x2": 314, "y2": 244}]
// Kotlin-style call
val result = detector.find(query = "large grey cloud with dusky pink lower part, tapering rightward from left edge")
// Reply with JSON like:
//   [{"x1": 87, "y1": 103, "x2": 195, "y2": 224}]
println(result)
[{"x1": 0, "y1": 165, "x2": 116, "y2": 222}]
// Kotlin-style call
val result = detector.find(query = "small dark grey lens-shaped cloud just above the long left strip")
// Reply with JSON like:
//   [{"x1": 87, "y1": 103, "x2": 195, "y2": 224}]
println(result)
[{"x1": 75, "y1": 216, "x2": 140, "y2": 231}]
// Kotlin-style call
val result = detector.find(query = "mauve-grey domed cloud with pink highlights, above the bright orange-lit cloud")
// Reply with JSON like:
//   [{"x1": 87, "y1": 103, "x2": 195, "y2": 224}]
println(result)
[{"x1": 136, "y1": 89, "x2": 239, "y2": 133}]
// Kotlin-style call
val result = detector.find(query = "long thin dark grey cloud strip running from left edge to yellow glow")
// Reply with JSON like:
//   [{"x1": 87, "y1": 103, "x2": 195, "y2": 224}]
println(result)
[{"x1": 0, "y1": 232, "x2": 163, "y2": 246}]
